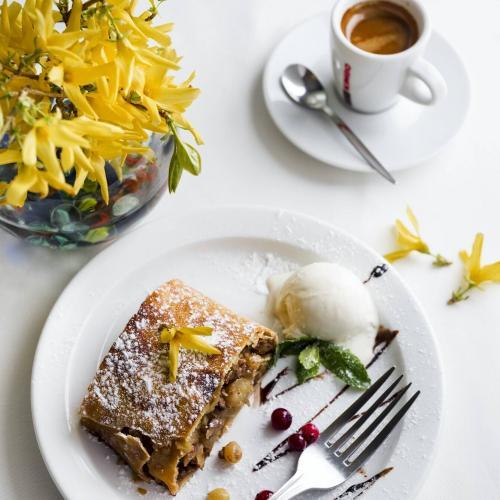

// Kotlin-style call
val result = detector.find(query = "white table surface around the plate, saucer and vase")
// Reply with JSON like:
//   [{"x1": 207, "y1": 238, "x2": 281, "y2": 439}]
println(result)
[{"x1": 0, "y1": 0, "x2": 500, "y2": 500}]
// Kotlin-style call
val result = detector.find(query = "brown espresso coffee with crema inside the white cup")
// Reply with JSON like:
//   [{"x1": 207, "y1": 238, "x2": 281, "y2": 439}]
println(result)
[{"x1": 341, "y1": 1, "x2": 419, "y2": 54}]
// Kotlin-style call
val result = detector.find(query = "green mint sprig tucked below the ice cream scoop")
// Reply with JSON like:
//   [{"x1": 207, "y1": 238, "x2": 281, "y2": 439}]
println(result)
[{"x1": 273, "y1": 337, "x2": 371, "y2": 390}]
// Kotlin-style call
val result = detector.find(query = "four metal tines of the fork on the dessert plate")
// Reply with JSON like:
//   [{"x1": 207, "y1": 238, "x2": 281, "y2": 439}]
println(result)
[{"x1": 321, "y1": 367, "x2": 420, "y2": 471}]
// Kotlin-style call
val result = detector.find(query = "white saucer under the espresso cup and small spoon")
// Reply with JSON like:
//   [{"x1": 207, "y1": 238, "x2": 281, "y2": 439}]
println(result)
[{"x1": 263, "y1": 13, "x2": 470, "y2": 172}]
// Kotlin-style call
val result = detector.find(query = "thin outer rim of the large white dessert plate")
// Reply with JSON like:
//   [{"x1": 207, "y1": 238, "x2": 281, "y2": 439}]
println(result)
[{"x1": 30, "y1": 204, "x2": 445, "y2": 498}]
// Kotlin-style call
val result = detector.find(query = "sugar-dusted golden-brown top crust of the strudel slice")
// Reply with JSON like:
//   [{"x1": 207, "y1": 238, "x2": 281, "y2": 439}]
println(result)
[{"x1": 82, "y1": 280, "x2": 270, "y2": 446}]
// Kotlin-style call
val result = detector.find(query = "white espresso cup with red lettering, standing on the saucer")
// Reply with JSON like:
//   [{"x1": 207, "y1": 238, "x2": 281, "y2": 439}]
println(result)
[{"x1": 330, "y1": 0, "x2": 447, "y2": 113}]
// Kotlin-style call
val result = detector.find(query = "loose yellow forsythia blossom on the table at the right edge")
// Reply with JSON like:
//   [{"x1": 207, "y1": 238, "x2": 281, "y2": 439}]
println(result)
[{"x1": 448, "y1": 233, "x2": 500, "y2": 304}]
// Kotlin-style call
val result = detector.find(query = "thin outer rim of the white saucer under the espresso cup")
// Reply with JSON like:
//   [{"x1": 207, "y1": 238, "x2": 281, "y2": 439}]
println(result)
[{"x1": 261, "y1": 11, "x2": 471, "y2": 174}]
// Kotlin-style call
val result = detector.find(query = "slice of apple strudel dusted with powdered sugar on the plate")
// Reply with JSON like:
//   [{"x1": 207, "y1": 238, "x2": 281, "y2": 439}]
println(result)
[{"x1": 80, "y1": 280, "x2": 277, "y2": 495}]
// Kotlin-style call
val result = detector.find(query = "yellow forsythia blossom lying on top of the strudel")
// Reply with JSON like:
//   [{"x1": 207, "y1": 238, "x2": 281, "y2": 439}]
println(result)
[{"x1": 160, "y1": 326, "x2": 220, "y2": 382}]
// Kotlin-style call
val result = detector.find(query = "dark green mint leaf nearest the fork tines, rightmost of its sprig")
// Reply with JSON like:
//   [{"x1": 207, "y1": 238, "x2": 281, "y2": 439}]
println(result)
[{"x1": 319, "y1": 342, "x2": 371, "y2": 390}]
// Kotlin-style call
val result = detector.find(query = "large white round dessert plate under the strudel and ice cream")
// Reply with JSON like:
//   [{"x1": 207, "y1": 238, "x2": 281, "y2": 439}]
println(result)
[{"x1": 31, "y1": 207, "x2": 442, "y2": 500}]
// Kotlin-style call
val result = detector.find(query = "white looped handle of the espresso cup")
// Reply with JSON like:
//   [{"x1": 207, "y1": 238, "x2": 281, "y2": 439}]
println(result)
[{"x1": 399, "y1": 58, "x2": 448, "y2": 105}]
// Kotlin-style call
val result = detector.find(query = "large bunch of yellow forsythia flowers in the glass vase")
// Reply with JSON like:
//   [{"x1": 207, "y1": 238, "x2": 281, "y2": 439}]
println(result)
[{"x1": 0, "y1": 0, "x2": 201, "y2": 206}]
